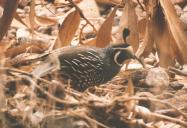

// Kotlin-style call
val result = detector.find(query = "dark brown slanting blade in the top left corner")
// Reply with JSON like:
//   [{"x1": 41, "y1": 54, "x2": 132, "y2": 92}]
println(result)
[{"x1": 0, "y1": 0, "x2": 19, "y2": 41}]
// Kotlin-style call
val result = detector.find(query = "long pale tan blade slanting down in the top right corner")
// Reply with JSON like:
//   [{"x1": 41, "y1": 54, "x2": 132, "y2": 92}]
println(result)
[{"x1": 160, "y1": 0, "x2": 187, "y2": 63}]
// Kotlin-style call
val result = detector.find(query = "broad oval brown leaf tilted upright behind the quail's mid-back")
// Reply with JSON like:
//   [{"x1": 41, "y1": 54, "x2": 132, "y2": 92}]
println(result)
[{"x1": 58, "y1": 10, "x2": 80, "y2": 47}]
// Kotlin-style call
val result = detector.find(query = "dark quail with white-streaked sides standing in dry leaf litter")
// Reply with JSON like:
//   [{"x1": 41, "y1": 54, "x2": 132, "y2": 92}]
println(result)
[{"x1": 32, "y1": 30, "x2": 136, "y2": 91}]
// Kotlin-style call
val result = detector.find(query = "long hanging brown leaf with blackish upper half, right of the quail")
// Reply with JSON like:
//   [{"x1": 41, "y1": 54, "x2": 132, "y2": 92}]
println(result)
[{"x1": 152, "y1": 4, "x2": 175, "y2": 68}]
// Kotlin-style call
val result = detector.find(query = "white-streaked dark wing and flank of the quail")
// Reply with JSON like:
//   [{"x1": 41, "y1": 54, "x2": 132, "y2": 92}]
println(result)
[{"x1": 58, "y1": 47, "x2": 105, "y2": 86}]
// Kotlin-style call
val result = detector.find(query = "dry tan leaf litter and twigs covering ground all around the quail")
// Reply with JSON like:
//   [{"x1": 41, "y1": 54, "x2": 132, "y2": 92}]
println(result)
[{"x1": 0, "y1": 0, "x2": 187, "y2": 128}]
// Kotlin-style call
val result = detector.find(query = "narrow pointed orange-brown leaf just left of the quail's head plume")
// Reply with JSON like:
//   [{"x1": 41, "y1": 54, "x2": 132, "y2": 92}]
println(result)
[{"x1": 96, "y1": 6, "x2": 118, "y2": 48}]
